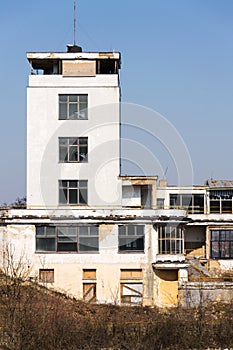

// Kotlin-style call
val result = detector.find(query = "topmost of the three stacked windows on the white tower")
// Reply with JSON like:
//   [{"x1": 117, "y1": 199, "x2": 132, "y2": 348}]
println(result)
[{"x1": 59, "y1": 95, "x2": 88, "y2": 120}]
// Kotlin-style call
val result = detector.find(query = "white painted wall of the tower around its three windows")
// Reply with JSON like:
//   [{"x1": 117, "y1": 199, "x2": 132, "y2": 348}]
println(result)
[{"x1": 27, "y1": 75, "x2": 121, "y2": 208}]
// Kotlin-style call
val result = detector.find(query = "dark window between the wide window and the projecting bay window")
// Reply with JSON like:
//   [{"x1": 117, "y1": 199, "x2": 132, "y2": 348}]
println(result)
[{"x1": 118, "y1": 225, "x2": 145, "y2": 252}]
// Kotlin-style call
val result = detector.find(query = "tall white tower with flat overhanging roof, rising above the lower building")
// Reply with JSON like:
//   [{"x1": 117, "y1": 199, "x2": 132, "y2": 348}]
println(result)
[{"x1": 27, "y1": 45, "x2": 121, "y2": 208}]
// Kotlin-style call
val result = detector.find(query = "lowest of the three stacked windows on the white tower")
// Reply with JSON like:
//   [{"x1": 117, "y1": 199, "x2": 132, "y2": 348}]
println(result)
[{"x1": 59, "y1": 180, "x2": 87, "y2": 205}]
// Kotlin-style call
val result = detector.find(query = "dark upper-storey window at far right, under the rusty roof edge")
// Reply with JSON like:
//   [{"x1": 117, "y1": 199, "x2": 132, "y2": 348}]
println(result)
[{"x1": 209, "y1": 190, "x2": 233, "y2": 214}]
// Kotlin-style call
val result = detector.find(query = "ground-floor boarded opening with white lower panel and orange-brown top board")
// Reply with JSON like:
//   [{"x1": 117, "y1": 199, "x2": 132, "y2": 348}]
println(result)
[{"x1": 121, "y1": 269, "x2": 143, "y2": 305}]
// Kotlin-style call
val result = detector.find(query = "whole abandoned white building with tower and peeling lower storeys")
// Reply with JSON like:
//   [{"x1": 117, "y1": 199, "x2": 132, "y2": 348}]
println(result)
[{"x1": 0, "y1": 46, "x2": 233, "y2": 306}]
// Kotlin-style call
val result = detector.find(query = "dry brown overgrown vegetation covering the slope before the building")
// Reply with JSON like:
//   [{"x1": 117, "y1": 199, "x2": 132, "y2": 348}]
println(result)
[{"x1": 0, "y1": 273, "x2": 233, "y2": 350}]
